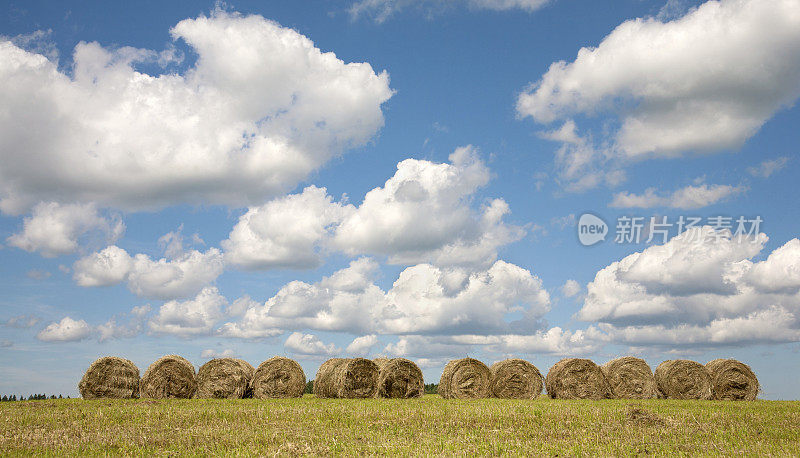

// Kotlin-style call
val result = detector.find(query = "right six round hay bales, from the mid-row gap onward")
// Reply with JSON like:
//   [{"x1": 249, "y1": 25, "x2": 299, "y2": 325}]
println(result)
[{"x1": 439, "y1": 356, "x2": 759, "y2": 401}]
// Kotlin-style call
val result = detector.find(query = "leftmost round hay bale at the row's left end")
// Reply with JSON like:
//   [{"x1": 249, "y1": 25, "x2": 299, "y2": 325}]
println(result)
[{"x1": 78, "y1": 356, "x2": 139, "y2": 399}]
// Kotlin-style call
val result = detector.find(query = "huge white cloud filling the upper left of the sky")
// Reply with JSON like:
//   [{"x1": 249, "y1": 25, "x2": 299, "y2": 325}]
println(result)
[{"x1": 0, "y1": 10, "x2": 392, "y2": 214}]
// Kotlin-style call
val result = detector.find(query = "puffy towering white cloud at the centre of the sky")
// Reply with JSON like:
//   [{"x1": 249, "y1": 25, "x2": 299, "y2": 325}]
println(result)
[{"x1": 333, "y1": 146, "x2": 524, "y2": 265}]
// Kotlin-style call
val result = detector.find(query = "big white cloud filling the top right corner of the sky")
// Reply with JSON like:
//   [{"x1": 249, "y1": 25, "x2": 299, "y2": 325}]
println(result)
[{"x1": 517, "y1": 0, "x2": 800, "y2": 189}]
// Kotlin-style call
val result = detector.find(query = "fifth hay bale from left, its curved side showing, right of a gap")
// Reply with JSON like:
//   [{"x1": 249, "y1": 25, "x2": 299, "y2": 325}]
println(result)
[{"x1": 314, "y1": 358, "x2": 380, "y2": 398}]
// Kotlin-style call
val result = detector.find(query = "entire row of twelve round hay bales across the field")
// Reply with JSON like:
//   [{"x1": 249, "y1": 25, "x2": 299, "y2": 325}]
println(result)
[{"x1": 78, "y1": 355, "x2": 759, "y2": 400}]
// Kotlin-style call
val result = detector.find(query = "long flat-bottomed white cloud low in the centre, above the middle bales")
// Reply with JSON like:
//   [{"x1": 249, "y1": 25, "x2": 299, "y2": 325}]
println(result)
[{"x1": 221, "y1": 258, "x2": 550, "y2": 338}]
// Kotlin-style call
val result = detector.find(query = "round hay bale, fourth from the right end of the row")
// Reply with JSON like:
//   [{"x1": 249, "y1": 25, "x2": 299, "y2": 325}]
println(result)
[{"x1": 545, "y1": 358, "x2": 611, "y2": 399}]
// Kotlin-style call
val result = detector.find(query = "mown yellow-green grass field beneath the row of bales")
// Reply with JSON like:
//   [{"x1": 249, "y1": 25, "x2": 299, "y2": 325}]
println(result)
[{"x1": 0, "y1": 395, "x2": 800, "y2": 456}]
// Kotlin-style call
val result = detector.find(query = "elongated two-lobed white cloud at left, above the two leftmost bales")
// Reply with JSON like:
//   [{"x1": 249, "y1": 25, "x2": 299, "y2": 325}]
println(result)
[{"x1": 73, "y1": 245, "x2": 224, "y2": 300}]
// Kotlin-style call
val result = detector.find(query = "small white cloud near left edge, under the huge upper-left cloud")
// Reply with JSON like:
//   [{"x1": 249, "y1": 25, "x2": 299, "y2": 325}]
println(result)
[{"x1": 6, "y1": 201, "x2": 125, "y2": 258}]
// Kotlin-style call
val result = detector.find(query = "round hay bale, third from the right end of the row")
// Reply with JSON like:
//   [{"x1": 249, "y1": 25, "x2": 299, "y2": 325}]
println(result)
[{"x1": 600, "y1": 356, "x2": 658, "y2": 399}]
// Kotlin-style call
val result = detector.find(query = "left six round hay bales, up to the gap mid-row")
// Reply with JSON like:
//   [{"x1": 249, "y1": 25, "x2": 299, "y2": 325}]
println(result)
[{"x1": 78, "y1": 355, "x2": 424, "y2": 399}]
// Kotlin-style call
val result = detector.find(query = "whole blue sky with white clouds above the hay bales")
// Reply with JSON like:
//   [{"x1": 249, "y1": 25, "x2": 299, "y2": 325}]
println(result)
[{"x1": 0, "y1": 0, "x2": 800, "y2": 399}]
